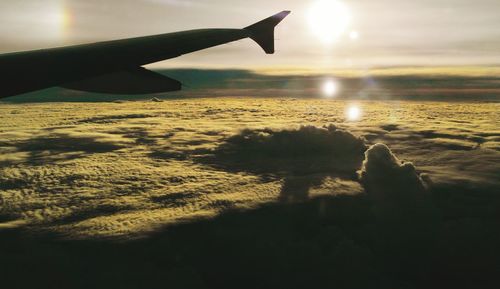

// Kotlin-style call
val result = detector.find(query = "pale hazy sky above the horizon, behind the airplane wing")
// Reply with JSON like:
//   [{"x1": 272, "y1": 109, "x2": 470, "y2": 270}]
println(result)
[{"x1": 0, "y1": 0, "x2": 500, "y2": 70}]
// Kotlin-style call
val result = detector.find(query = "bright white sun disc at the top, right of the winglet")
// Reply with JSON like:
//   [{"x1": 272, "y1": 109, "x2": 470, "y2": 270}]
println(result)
[{"x1": 308, "y1": 0, "x2": 351, "y2": 44}]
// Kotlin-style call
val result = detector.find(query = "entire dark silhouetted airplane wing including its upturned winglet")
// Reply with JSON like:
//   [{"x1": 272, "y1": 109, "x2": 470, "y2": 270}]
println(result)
[{"x1": 0, "y1": 11, "x2": 290, "y2": 98}]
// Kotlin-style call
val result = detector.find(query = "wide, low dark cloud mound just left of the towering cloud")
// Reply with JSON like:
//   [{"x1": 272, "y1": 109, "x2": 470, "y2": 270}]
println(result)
[{"x1": 205, "y1": 125, "x2": 366, "y2": 176}]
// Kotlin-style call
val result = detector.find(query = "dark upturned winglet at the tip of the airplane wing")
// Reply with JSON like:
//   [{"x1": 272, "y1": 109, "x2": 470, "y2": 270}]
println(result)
[{"x1": 244, "y1": 11, "x2": 291, "y2": 54}]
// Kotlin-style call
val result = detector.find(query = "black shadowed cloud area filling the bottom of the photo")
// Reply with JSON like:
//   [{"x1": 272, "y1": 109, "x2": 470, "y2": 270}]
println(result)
[{"x1": 0, "y1": 182, "x2": 500, "y2": 289}]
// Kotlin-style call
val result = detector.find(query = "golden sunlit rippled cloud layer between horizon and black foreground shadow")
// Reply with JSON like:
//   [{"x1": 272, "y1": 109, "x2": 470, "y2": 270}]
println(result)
[{"x1": 0, "y1": 98, "x2": 500, "y2": 238}]
